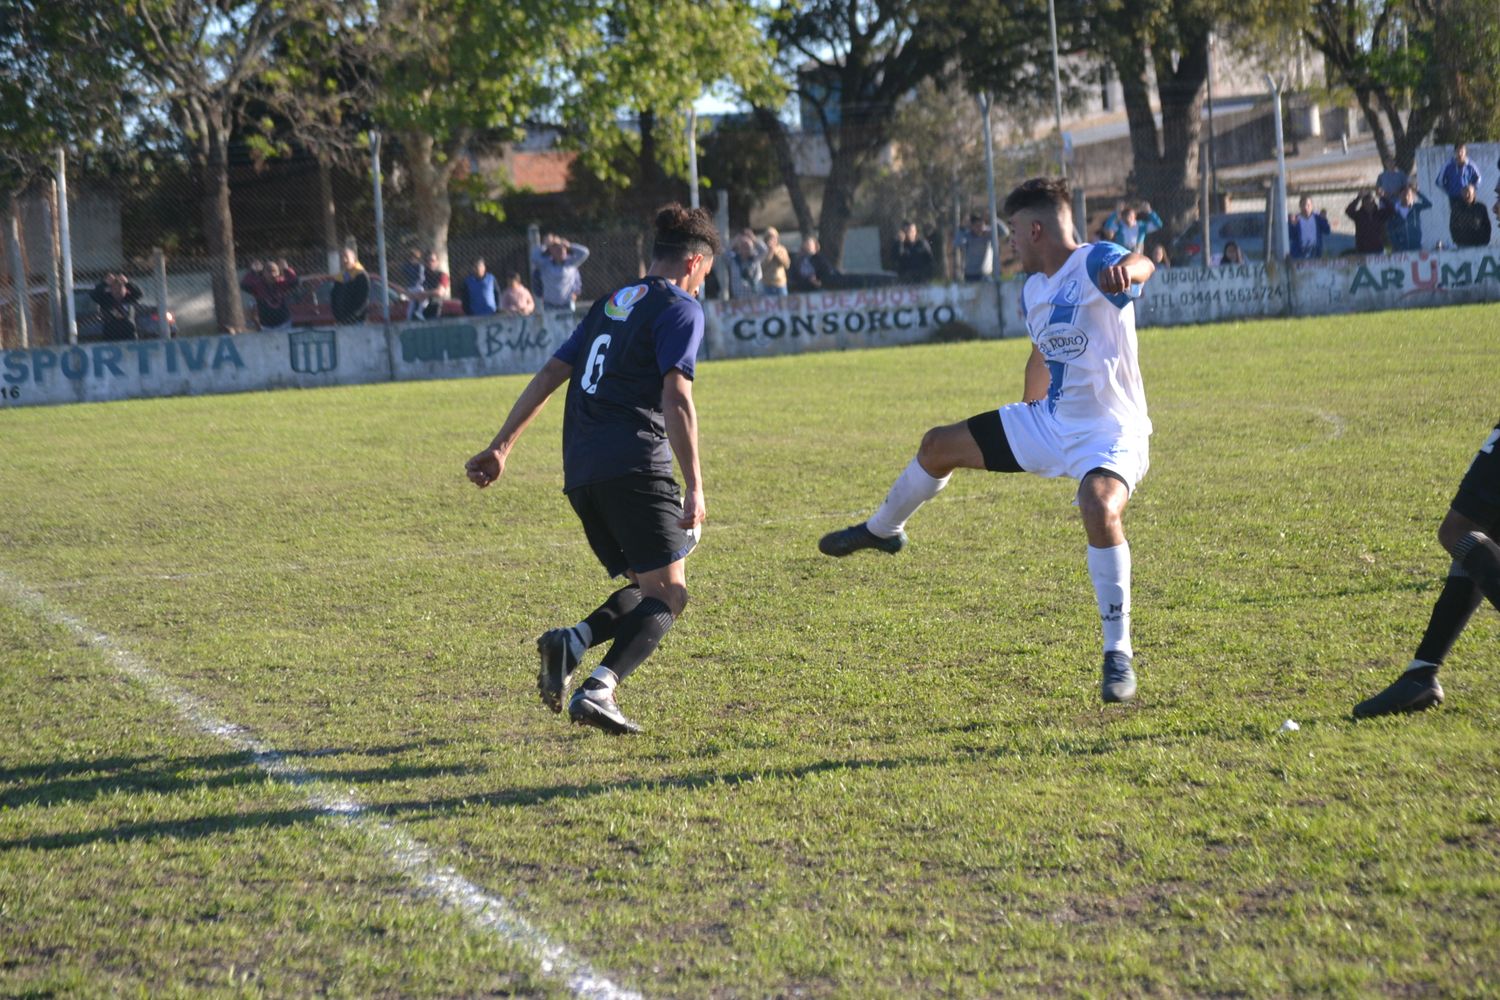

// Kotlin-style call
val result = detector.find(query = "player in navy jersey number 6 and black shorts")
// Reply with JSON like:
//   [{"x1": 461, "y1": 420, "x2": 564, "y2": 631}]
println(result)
[{"x1": 465, "y1": 204, "x2": 720, "y2": 735}]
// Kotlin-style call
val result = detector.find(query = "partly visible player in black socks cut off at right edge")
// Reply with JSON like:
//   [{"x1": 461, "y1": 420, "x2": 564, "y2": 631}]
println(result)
[{"x1": 1355, "y1": 424, "x2": 1500, "y2": 718}]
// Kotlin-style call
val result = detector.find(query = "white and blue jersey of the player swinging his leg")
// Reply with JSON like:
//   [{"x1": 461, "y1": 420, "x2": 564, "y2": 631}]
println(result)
[{"x1": 1022, "y1": 243, "x2": 1151, "y2": 439}]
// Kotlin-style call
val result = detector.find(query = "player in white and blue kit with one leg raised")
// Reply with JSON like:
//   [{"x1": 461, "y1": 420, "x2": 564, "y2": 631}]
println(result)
[{"x1": 818, "y1": 178, "x2": 1157, "y2": 702}]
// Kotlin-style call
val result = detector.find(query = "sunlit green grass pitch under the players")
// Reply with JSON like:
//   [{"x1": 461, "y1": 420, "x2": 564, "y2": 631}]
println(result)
[{"x1": 0, "y1": 306, "x2": 1500, "y2": 997}]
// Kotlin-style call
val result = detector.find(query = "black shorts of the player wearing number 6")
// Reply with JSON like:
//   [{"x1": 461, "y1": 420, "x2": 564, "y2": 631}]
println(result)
[{"x1": 567, "y1": 475, "x2": 698, "y2": 576}]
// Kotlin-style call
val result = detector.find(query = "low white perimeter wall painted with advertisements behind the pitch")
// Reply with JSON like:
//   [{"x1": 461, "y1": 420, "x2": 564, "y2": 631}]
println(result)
[{"x1": 0, "y1": 247, "x2": 1500, "y2": 406}]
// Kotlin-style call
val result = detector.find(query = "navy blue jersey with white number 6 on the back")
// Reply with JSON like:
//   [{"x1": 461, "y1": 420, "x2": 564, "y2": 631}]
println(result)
[{"x1": 552, "y1": 276, "x2": 704, "y2": 492}]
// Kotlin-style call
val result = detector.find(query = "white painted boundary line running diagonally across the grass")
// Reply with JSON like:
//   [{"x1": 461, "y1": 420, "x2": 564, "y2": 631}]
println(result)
[{"x1": 0, "y1": 570, "x2": 641, "y2": 1000}]
